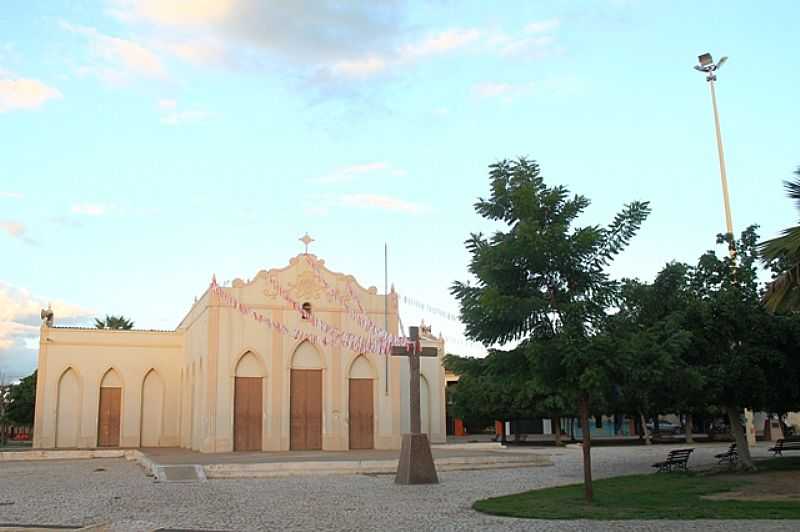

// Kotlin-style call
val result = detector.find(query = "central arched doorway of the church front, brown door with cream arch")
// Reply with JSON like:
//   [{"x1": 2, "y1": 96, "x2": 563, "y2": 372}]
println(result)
[{"x1": 289, "y1": 342, "x2": 322, "y2": 451}]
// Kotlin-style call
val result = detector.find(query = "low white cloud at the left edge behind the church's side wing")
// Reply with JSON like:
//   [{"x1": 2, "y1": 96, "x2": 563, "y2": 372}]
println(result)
[{"x1": 0, "y1": 281, "x2": 94, "y2": 377}]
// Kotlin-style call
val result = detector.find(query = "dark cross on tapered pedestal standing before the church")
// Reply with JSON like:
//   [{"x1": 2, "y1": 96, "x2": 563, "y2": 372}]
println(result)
[{"x1": 392, "y1": 327, "x2": 439, "y2": 484}]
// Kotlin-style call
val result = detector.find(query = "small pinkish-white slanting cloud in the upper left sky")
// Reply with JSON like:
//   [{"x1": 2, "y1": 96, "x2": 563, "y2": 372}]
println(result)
[{"x1": 61, "y1": 22, "x2": 167, "y2": 85}]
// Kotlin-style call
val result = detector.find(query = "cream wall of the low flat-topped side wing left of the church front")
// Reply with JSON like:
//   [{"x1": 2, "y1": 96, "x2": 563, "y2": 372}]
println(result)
[{"x1": 34, "y1": 327, "x2": 183, "y2": 448}]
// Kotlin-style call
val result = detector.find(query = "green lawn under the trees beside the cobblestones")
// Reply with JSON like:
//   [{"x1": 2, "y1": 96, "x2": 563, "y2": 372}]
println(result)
[{"x1": 473, "y1": 458, "x2": 800, "y2": 520}]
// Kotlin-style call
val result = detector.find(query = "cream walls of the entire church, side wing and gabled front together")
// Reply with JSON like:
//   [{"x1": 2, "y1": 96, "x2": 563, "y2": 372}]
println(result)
[{"x1": 34, "y1": 255, "x2": 445, "y2": 452}]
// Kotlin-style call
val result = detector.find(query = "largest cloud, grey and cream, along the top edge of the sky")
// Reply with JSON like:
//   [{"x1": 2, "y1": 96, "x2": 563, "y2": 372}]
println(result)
[{"x1": 107, "y1": 0, "x2": 560, "y2": 85}]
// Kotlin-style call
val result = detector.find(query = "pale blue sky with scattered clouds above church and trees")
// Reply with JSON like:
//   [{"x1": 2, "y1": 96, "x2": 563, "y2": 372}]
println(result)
[{"x1": 0, "y1": 0, "x2": 800, "y2": 375}]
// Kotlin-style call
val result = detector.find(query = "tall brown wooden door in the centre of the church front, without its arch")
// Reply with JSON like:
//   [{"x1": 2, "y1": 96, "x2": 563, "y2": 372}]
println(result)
[{"x1": 289, "y1": 369, "x2": 322, "y2": 451}]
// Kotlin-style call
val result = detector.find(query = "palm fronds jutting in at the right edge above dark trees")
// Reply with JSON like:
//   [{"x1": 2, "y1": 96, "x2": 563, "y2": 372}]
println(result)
[{"x1": 758, "y1": 168, "x2": 800, "y2": 312}]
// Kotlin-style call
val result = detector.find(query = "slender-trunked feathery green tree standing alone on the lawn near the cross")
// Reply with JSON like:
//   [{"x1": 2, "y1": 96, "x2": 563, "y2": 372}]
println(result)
[{"x1": 451, "y1": 158, "x2": 650, "y2": 501}]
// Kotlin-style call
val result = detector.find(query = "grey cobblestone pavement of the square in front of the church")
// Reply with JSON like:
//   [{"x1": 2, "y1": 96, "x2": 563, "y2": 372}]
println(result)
[{"x1": 0, "y1": 444, "x2": 800, "y2": 532}]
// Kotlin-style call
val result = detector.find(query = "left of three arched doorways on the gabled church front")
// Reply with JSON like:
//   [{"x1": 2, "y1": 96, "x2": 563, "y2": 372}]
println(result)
[{"x1": 233, "y1": 351, "x2": 264, "y2": 451}]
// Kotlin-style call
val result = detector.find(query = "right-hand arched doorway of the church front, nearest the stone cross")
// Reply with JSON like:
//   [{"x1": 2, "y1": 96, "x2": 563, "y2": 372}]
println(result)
[{"x1": 348, "y1": 355, "x2": 375, "y2": 449}]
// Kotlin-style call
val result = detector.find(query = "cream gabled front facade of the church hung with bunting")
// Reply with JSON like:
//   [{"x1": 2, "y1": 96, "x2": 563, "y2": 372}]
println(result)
[{"x1": 198, "y1": 258, "x2": 412, "y2": 452}]
